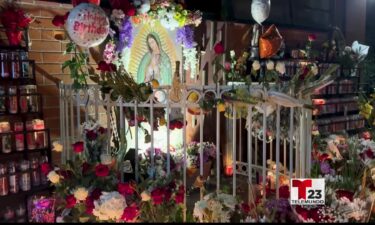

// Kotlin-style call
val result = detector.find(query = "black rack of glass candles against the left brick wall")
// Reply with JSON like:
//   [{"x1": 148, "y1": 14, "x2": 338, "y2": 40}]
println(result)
[{"x1": 0, "y1": 46, "x2": 52, "y2": 222}]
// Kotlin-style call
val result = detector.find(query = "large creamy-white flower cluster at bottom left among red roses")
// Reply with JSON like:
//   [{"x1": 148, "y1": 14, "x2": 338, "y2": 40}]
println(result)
[{"x1": 93, "y1": 191, "x2": 126, "y2": 221}]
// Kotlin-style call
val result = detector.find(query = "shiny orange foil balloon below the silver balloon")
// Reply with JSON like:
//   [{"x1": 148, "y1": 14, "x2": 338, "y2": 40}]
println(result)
[{"x1": 259, "y1": 25, "x2": 283, "y2": 59}]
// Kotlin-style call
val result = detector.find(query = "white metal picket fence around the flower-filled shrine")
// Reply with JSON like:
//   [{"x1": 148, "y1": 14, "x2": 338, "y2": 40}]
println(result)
[{"x1": 59, "y1": 84, "x2": 312, "y2": 206}]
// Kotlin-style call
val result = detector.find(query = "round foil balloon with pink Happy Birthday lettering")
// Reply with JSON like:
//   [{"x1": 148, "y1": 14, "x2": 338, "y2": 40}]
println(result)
[{"x1": 66, "y1": 3, "x2": 109, "y2": 48}]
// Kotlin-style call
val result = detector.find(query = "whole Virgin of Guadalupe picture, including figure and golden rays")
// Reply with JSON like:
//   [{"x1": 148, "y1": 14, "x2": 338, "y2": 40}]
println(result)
[{"x1": 122, "y1": 21, "x2": 182, "y2": 85}]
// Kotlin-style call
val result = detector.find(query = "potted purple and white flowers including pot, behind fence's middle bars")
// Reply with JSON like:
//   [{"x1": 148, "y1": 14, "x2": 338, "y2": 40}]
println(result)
[{"x1": 187, "y1": 142, "x2": 217, "y2": 179}]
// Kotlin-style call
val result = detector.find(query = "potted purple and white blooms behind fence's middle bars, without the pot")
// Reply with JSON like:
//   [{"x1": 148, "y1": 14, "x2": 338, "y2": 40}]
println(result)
[{"x1": 186, "y1": 141, "x2": 217, "y2": 168}]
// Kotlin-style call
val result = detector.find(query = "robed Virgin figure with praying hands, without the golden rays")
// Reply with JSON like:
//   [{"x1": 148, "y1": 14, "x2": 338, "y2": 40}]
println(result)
[{"x1": 137, "y1": 32, "x2": 172, "y2": 85}]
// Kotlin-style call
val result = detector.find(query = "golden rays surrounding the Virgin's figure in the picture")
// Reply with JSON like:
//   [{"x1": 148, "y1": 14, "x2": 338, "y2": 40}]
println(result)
[{"x1": 128, "y1": 22, "x2": 178, "y2": 80}]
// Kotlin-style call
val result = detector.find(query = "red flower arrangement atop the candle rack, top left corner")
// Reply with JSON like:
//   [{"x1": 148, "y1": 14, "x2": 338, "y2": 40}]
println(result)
[{"x1": 0, "y1": 1, "x2": 33, "y2": 46}]
